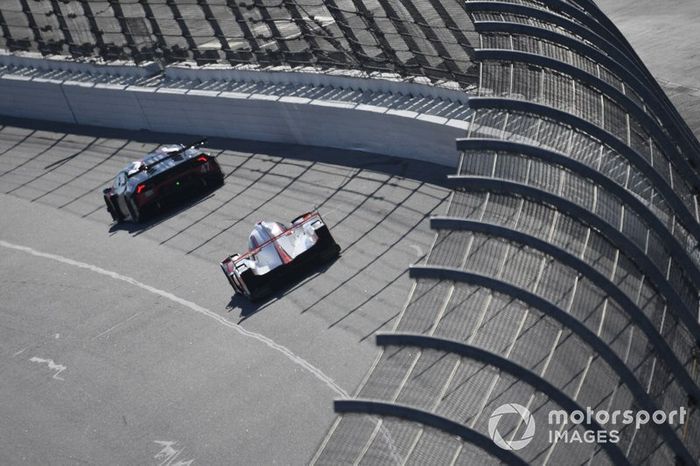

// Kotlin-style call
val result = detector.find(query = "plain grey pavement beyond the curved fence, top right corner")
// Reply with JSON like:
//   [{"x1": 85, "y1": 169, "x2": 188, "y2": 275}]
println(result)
[{"x1": 596, "y1": 0, "x2": 700, "y2": 136}]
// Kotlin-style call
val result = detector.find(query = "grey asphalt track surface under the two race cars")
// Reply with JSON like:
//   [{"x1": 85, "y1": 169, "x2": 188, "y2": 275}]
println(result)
[{"x1": 0, "y1": 121, "x2": 448, "y2": 465}]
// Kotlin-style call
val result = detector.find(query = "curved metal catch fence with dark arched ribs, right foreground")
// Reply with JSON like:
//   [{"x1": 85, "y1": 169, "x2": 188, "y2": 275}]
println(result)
[{"x1": 312, "y1": 0, "x2": 700, "y2": 465}]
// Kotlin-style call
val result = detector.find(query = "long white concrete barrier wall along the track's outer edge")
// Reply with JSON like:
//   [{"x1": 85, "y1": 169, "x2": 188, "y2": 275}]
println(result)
[{"x1": 0, "y1": 57, "x2": 468, "y2": 166}]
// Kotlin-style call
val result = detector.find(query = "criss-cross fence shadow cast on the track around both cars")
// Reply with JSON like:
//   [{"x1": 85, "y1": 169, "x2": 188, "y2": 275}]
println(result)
[{"x1": 0, "y1": 118, "x2": 456, "y2": 339}]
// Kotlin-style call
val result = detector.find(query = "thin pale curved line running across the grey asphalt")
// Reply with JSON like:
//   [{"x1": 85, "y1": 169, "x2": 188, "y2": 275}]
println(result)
[{"x1": 0, "y1": 240, "x2": 348, "y2": 398}]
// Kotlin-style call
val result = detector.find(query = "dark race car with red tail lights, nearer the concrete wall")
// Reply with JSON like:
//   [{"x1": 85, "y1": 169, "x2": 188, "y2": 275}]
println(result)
[{"x1": 102, "y1": 139, "x2": 224, "y2": 222}]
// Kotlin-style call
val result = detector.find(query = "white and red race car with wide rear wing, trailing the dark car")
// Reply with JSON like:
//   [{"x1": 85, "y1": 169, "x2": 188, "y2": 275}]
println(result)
[{"x1": 220, "y1": 211, "x2": 340, "y2": 301}]
